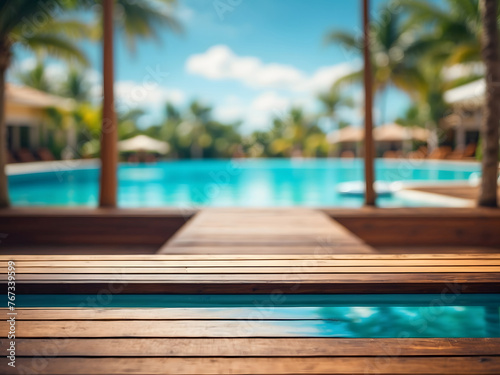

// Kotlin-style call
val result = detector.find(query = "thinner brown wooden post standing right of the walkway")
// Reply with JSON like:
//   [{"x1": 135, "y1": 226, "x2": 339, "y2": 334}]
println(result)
[{"x1": 363, "y1": 0, "x2": 375, "y2": 206}]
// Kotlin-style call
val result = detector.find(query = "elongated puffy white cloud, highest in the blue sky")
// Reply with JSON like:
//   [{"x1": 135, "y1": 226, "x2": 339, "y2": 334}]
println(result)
[{"x1": 186, "y1": 45, "x2": 357, "y2": 92}]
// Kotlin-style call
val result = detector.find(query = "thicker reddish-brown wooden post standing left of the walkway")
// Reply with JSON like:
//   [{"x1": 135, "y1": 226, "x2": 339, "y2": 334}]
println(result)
[{"x1": 99, "y1": 0, "x2": 118, "y2": 207}]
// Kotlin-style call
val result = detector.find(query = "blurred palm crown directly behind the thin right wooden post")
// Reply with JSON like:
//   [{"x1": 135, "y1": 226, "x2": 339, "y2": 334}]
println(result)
[{"x1": 325, "y1": 5, "x2": 422, "y2": 122}]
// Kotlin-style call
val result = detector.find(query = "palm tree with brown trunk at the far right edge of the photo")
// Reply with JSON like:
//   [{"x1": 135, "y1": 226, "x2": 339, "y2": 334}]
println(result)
[{"x1": 403, "y1": 0, "x2": 500, "y2": 207}]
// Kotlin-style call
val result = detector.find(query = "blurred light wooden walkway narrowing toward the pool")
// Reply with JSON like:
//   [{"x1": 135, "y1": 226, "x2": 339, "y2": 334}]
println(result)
[{"x1": 159, "y1": 208, "x2": 374, "y2": 254}]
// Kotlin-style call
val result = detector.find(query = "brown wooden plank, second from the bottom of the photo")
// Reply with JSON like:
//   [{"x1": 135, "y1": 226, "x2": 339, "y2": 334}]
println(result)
[{"x1": 4, "y1": 338, "x2": 500, "y2": 357}]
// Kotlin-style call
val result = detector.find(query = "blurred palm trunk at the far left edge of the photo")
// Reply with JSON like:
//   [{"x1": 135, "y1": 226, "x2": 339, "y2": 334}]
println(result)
[{"x1": 0, "y1": 41, "x2": 11, "y2": 208}]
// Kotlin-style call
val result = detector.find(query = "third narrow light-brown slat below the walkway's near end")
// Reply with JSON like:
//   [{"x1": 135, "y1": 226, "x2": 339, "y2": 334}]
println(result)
[{"x1": 6, "y1": 265, "x2": 500, "y2": 275}]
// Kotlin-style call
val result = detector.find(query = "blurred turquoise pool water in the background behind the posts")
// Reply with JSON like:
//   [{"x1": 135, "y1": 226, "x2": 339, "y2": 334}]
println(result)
[{"x1": 9, "y1": 159, "x2": 480, "y2": 207}]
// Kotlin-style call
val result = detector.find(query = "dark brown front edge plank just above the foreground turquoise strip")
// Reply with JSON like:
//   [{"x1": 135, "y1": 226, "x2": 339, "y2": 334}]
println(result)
[{"x1": 10, "y1": 280, "x2": 500, "y2": 294}]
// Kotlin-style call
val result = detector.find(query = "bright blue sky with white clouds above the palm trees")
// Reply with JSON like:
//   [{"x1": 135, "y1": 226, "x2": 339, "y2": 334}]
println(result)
[{"x1": 9, "y1": 0, "x2": 409, "y2": 132}]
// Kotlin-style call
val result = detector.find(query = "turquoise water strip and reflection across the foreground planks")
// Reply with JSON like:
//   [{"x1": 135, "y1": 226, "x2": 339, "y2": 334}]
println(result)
[{"x1": 16, "y1": 294, "x2": 500, "y2": 338}]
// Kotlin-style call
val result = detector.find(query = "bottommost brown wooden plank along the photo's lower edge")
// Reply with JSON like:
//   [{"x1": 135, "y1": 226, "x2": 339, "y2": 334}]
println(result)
[{"x1": 0, "y1": 356, "x2": 500, "y2": 375}]
